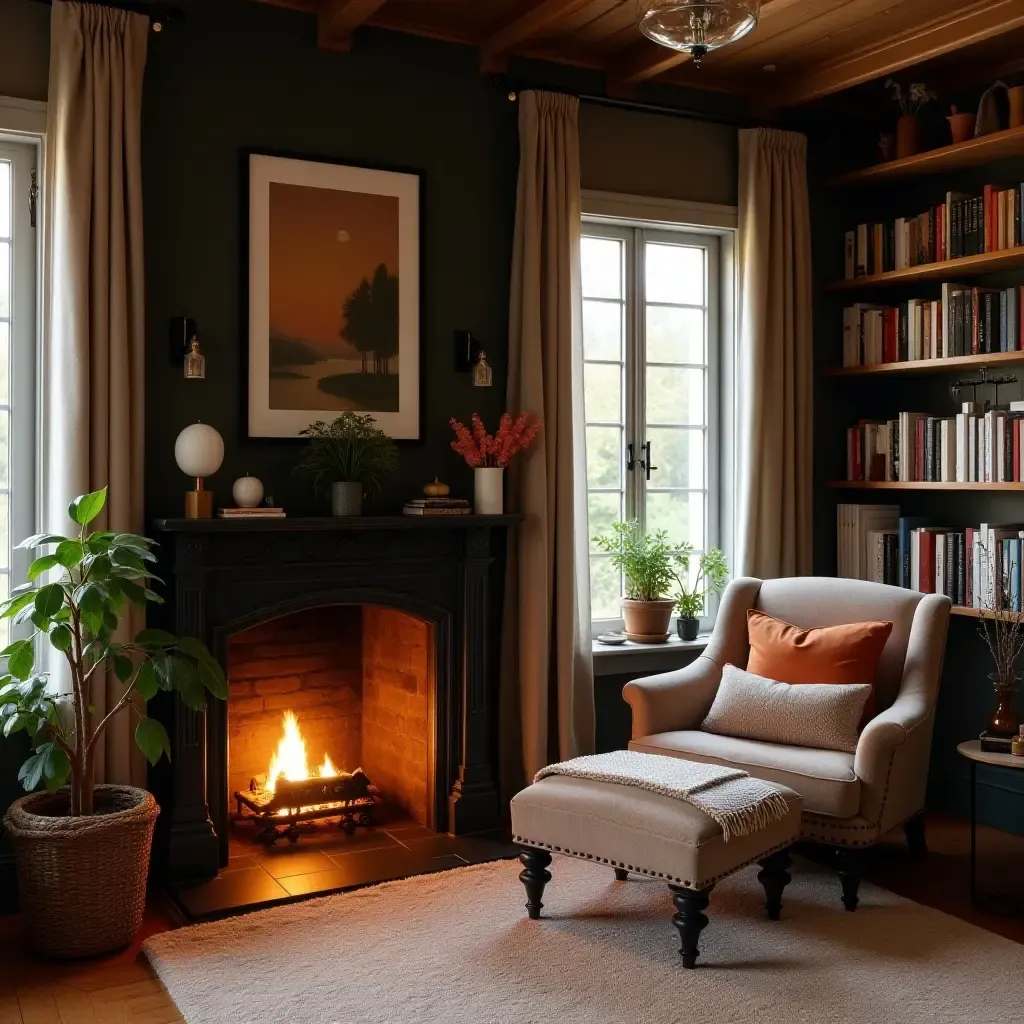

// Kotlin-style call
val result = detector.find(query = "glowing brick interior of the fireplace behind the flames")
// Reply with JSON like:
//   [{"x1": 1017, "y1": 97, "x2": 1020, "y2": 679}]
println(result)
[{"x1": 227, "y1": 605, "x2": 433, "y2": 824}]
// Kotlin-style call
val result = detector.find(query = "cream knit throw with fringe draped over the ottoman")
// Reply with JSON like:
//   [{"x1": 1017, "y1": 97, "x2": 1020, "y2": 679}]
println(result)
[{"x1": 534, "y1": 751, "x2": 788, "y2": 843}]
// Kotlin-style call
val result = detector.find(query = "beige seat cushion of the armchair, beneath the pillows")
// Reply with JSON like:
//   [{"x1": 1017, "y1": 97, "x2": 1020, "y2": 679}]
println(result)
[{"x1": 630, "y1": 729, "x2": 861, "y2": 818}]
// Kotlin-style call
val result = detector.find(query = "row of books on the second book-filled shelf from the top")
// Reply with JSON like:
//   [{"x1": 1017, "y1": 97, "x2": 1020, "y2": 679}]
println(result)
[{"x1": 843, "y1": 283, "x2": 1024, "y2": 367}]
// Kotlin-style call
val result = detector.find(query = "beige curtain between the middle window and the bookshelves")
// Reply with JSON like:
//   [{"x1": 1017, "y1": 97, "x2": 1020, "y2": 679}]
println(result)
[{"x1": 736, "y1": 128, "x2": 813, "y2": 579}]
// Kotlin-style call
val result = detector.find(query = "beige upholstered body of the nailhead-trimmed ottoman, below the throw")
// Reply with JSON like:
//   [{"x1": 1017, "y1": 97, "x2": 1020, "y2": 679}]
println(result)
[{"x1": 512, "y1": 775, "x2": 803, "y2": 889}]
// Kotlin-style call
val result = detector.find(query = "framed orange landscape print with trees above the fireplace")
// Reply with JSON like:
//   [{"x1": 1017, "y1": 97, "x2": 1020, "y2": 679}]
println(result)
[{"x1": 246, "y1": 153, "x2": 421, "y2": 439}]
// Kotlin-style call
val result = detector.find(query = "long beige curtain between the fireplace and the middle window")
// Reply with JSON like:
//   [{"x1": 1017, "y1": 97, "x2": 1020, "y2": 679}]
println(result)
[{"x1": 502, "y1": 92, "x2": 594, "y2": 793}]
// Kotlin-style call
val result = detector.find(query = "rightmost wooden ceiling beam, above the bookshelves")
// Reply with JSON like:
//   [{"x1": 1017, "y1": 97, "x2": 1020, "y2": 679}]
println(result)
[{"x1": 763, "y1": 0, "x2": 1024, "y2": 110}]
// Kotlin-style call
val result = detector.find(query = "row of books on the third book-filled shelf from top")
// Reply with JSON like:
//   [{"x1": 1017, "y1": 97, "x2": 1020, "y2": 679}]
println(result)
[{"x1": 846, "y1": 401, "x2": 1024, "y2": 483}]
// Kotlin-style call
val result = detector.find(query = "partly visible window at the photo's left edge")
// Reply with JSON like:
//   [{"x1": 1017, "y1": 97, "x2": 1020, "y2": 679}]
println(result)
[{"x1": 0, "y1": 138, "x2": 37, "y2": 647}]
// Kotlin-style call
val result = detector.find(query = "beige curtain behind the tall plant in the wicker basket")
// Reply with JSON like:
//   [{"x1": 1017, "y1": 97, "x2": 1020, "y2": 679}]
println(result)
[{"x1": 41, "y1": 0, "x2": 150, "y2": 783}]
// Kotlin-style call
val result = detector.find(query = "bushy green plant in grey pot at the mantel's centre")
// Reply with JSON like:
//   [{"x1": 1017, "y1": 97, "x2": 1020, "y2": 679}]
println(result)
[{"x1": 295, "y1": 413, "x2": 398, "y2": 516}]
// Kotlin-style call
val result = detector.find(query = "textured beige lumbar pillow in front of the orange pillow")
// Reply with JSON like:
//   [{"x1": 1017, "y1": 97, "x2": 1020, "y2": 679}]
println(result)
[{"x1": 700, "y1": 665, "x2": 871, "y2": 754}]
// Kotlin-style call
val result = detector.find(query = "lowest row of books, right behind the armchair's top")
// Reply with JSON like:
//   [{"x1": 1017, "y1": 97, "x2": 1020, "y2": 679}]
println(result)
[{"x1": 837, "y1": 505, "x2": 1024, "y2": 611}]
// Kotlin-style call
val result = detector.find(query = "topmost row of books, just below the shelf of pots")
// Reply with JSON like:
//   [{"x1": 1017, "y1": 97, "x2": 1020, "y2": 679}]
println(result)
[{"x1": 845, "y1": 183, "x2": 1024, "y2": 280}]
